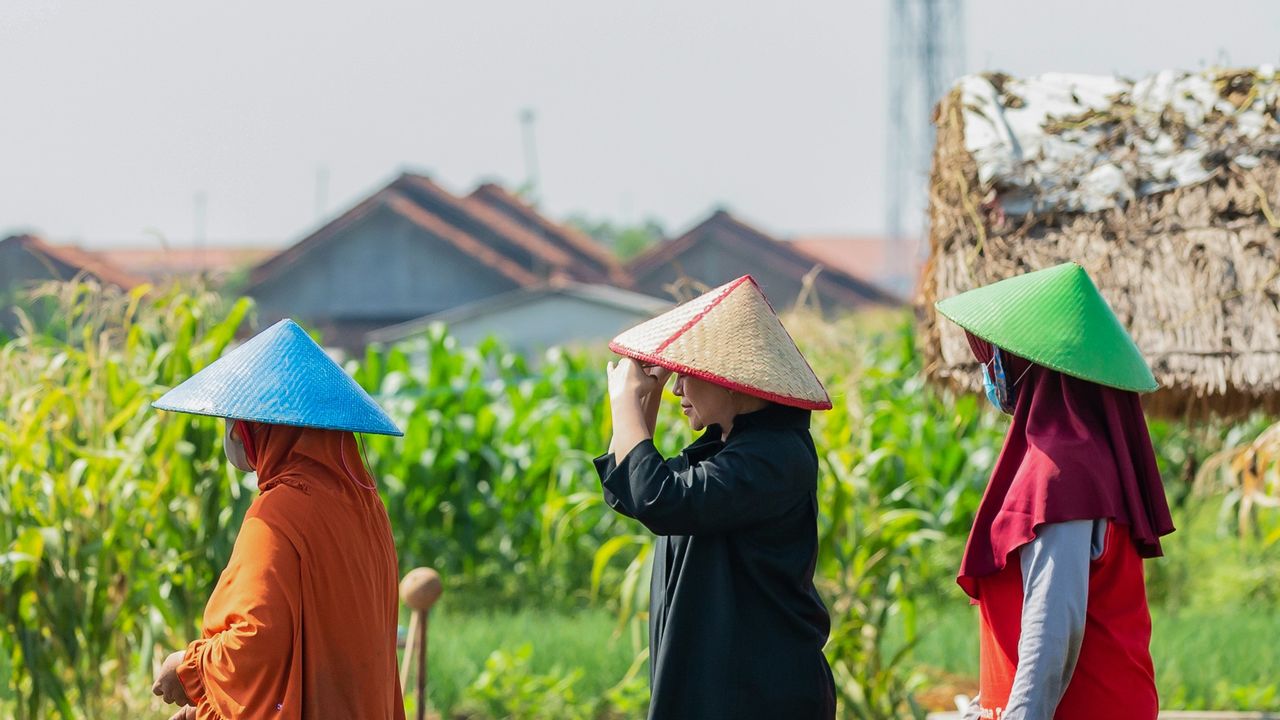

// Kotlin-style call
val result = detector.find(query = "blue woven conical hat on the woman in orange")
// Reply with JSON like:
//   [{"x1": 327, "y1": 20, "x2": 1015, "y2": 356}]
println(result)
[{"x1": 151, "y1": 319, "x2": 404, "y2": 436}]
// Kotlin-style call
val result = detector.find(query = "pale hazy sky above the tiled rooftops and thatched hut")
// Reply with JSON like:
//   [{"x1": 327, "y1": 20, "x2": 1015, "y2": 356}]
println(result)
[{"x1": 0, "y1": 0, "x2": 1280, "y2": 246}]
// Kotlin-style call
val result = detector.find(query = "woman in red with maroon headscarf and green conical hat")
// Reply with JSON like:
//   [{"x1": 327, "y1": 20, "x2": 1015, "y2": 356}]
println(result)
[{"x1": 937, "y1": 263, "x2": 1174, "y2": 720}]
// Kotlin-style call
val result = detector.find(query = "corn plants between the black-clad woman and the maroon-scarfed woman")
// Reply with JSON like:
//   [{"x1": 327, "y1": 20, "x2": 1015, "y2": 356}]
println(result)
[{"x1": 814, "y1": 316, "x2": 1000, "y2": 719}]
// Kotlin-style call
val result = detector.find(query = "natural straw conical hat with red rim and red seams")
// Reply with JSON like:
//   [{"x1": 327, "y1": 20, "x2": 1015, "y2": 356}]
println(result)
[{"x1": 609, "y1": 275, "x2": 831, "y2": 410}]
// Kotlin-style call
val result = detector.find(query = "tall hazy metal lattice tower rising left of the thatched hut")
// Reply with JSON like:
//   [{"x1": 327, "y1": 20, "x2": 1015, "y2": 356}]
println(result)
[{"x1": 886, "y1": 0, "x2": 964, "y2": 256}]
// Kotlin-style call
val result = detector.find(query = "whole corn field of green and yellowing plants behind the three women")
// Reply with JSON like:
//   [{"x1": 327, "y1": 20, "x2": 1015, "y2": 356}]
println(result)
[{"x1": 0, "y1": 284, "x2": 1274, "y2": 719}]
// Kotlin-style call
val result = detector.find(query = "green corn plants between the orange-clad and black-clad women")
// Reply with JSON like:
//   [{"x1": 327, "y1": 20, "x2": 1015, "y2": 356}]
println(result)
[{"x1": 351, "y1": 327, "x2": 623, "y2": 607}]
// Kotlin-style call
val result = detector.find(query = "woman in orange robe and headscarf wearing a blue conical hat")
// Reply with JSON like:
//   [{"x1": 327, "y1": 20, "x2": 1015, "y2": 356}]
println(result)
[{"x1": 145, "y1": 320, "x2": 404, "y2": 720}]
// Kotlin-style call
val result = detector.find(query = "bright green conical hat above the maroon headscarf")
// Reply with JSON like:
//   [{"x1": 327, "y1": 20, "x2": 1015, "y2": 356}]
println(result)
[{"x1": 936, "y1": 263, "x2": 1160, "y2": 392}]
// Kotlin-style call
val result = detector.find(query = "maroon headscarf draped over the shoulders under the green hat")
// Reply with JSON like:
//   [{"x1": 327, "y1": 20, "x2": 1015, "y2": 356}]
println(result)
[{"x1": 956, "y1": 334, "x2": 1174, "y2": 598}]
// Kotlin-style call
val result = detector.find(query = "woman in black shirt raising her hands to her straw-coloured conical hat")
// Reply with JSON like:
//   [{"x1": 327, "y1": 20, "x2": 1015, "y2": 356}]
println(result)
[{"x1": 596, "y1": 277, "x2": 836, "y2": 720}]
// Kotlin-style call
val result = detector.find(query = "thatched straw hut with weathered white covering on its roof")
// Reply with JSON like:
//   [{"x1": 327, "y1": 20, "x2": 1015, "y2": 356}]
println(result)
[{"x1": 918, "y1": 68, "x2": 1280, "y2": 418}]
